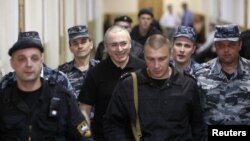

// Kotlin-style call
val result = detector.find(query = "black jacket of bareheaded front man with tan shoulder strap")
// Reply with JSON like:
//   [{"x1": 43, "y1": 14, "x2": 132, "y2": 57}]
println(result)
[{"x1": 104, "y1": 68, "x2": 205, "y2": 141}]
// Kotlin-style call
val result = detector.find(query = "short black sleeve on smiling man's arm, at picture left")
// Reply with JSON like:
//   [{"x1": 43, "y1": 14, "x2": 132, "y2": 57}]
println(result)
[{"x1": 78, "y1": 69, "x2": 97, "y2": 106}]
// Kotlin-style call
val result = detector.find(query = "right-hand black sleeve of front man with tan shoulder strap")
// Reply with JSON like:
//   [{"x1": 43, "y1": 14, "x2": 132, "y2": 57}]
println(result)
[{"x1": 191, "y1": 83, "x2": 205, "y2": 141}]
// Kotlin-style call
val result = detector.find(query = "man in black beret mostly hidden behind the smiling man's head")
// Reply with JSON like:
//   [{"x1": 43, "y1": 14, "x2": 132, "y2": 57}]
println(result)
[{"x1": 95, "y1": 15, "x2": 144, "y2": 61}]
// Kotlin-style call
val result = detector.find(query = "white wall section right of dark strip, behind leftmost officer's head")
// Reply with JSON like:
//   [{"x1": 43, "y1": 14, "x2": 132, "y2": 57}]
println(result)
[{"x1": 25, "y1": 0, "x2": 60, "y2": 68}]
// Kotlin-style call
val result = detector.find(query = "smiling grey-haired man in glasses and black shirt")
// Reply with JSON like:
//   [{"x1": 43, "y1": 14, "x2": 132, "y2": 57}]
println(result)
[{"x1": 78, "y1": 26, "x2": 145, "y2": 141}]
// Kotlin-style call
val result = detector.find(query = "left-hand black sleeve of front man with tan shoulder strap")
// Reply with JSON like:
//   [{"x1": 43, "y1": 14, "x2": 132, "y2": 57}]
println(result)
[{"x1": 104, "y1": 79, "x2": 133, "y2": 141}]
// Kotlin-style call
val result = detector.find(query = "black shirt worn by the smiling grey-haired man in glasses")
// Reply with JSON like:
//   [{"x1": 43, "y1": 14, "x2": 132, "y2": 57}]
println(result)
[{"x1": 78, "y1": 56, "x2": 145, "y2": 141}]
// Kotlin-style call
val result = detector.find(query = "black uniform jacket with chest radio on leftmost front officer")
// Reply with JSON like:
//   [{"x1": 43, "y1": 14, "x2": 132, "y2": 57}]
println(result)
[{"x1": 0, "y1": 80, "x2": 89, "y2": 141}]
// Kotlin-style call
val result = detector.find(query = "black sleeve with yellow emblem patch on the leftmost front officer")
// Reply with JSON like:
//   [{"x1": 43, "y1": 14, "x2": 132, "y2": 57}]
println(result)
[{"x1": 67, "y1": 93, "x2": 92, "y2": 141}]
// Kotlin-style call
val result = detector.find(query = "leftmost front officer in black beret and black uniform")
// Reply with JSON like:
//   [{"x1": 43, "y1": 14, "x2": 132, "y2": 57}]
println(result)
[{"x1": 0, "y1": 31, "x2": 92, "y2": 141}]
